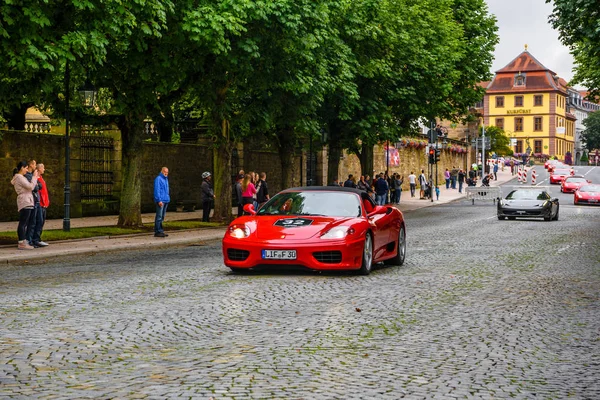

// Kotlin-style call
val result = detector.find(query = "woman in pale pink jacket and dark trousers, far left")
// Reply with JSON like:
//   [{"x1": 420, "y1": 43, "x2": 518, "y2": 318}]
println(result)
[{"x1": 10, "y1": 161, "x2": 38, "y2": 250}]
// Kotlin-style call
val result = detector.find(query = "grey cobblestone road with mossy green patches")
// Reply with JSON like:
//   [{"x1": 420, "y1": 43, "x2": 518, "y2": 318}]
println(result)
[{"x1": 0, "y1": 173, "x2": 600, "y2": 399}]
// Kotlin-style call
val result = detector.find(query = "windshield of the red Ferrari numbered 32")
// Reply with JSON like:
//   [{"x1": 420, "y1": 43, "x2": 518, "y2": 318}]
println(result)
[{"x1": 257, "y1": 190, "x2": 361, "y2": 217}]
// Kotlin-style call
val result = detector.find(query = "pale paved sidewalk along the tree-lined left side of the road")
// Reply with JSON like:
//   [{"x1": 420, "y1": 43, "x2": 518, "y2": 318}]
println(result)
[{"x1": 0, "y1": 168, "x2": 516, "y2": 265}]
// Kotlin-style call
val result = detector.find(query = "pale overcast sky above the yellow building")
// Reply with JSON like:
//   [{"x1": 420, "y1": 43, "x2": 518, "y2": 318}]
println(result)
[{"x1": 485, "y1": 0, "x2": 573, "y2": 82}]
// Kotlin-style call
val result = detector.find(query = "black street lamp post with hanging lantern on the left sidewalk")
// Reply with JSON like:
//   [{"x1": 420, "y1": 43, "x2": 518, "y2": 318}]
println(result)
[{"x1": 63, "y1": 61, "x2": 96, "y2": 232}]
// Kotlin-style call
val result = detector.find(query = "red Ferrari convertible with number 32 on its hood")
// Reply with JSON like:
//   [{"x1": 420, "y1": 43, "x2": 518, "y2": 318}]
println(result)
[{"x1": 223, "y1": 186, "x2": 406, "y2": 275}]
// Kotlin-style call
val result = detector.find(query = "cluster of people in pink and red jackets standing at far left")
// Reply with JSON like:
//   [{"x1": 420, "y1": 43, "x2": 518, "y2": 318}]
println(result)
[{"x1": 10, "y1": 159, "x2": 50, "y2": 250}]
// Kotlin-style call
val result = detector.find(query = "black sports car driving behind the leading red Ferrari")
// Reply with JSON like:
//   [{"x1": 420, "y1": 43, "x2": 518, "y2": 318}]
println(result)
[{"x1": 498, "y1": 186, "x2": 559, "y2": 221}]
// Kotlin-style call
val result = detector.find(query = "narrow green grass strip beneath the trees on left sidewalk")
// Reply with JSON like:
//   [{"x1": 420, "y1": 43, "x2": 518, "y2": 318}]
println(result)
[{"x1": 0, "y1": 220, "x2": 223, "y2": 245}]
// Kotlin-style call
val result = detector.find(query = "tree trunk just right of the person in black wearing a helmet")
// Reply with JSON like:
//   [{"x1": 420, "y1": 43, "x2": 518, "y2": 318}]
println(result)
[{"x1": 212, "y1": 119, "x2": 237, "y2": 222}]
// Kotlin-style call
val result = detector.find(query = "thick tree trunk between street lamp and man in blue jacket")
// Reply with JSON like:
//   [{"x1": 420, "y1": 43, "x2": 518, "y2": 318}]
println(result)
[{"x1": 117, "y1": 114, "x2": 145, "y2": 228}]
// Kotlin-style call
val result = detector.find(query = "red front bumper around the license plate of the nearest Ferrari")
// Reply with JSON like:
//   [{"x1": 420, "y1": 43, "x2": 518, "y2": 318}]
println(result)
[{"x1": 223, "y1": 237, "x2": 364, "y2": 271}]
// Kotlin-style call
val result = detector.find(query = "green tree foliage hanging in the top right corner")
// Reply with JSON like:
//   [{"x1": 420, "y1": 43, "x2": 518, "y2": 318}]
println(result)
[{"x1": 546, "y1": 0, "x2": 600, "y2": 99}]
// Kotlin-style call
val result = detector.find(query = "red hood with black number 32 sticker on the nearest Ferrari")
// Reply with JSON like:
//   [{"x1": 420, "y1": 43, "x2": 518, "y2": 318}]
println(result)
[{"x1": 255, "y1": 216, "x2": 352, "y2": 240}]
